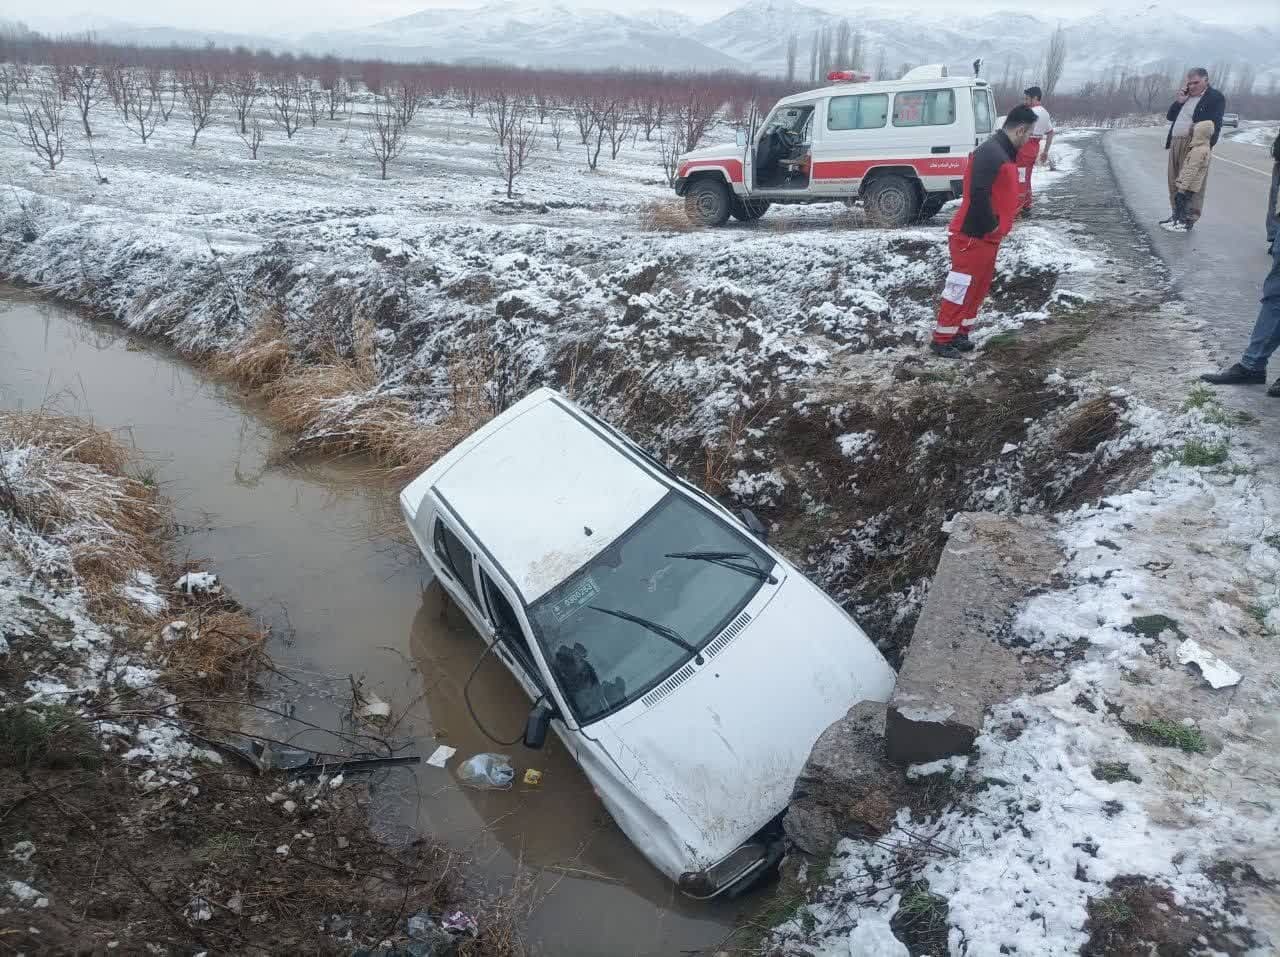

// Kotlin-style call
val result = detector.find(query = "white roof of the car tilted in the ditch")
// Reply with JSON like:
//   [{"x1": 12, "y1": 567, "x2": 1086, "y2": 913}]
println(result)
[{"x1": 433, "y1": 389, "x2": 669, "y2": 603}]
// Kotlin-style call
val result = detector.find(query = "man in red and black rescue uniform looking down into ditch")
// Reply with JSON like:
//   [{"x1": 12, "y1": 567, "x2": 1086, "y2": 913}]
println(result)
[{"x1": 929, "y1": 106, "x2": 1036, "y2": 358}]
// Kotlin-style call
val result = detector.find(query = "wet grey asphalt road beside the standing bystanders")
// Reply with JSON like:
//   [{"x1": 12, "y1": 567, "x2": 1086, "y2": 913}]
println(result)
[{"x1": 1103, "y1": 127, "x2": 1280, "y2": 411}]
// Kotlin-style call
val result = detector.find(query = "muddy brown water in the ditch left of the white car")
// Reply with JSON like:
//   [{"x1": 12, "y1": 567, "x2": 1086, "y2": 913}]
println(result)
[{"x1": 0, "y1": 287, "x2": 748, "y2": 957}]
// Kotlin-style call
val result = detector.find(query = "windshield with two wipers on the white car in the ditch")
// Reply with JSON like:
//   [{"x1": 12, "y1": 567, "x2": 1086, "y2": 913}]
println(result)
[{"x1": 530, "y1": 493, "x2": 773, "y2": 722}]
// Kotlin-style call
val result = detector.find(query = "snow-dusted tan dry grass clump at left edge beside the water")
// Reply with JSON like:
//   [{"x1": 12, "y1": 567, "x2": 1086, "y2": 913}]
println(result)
[{"x1": 0, "y1": 409, "x2": 168, "y2": 618}]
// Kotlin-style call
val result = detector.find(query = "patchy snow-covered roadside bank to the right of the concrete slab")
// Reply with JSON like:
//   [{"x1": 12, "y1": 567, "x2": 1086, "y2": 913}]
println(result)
[{"x1": 780, "y1": 396, "x2": 1280, "y2": 957}]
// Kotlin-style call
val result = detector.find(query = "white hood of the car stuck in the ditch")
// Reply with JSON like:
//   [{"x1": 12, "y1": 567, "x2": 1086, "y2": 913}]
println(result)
[{"x1": 611, "y1": 574, "x2": 895, "y2": 869}]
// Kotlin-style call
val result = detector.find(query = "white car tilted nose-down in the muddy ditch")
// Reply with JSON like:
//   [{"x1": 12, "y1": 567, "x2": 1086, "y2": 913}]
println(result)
[{"x1": 401, "y1": 389, "x2": 895, "y2": 898}]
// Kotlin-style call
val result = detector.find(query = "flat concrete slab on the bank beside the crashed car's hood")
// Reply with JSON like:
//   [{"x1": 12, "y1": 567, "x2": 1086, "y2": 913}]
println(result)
[{"x1": 884, "y1": 512, "x2": 1062, "y2": 764}]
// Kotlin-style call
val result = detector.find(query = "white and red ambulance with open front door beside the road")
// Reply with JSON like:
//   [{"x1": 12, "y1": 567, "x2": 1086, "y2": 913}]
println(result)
[{"x1": 675, "y1": 65, "x2": 997, "y2": 226}]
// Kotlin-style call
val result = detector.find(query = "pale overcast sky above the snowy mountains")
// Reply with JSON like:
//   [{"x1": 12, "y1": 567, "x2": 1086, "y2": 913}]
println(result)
[{"x1": 12, "y1": 0, "x2": 1280, "y2": 33}]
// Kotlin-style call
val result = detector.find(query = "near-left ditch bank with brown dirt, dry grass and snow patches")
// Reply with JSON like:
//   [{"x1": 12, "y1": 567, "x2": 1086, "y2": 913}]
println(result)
[{"x1": 0, "y1": 412, "x2": 521, "y2": 954}]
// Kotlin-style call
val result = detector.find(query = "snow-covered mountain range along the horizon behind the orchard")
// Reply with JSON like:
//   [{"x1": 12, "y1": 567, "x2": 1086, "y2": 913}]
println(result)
[{"x1": 17, "y1": 0, "x2": 1280, "y2": 90}]
